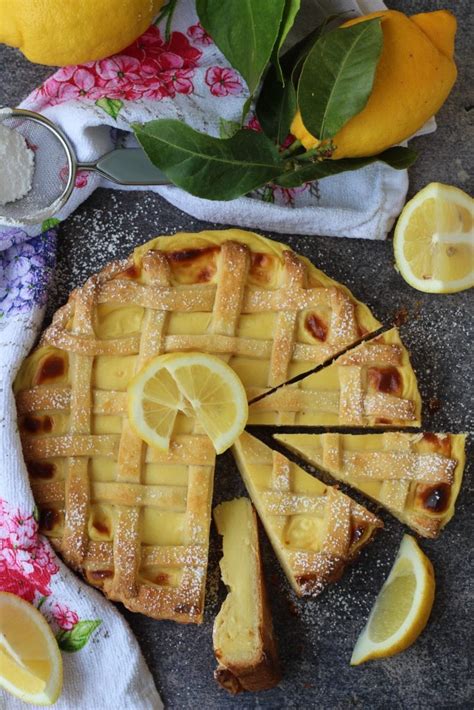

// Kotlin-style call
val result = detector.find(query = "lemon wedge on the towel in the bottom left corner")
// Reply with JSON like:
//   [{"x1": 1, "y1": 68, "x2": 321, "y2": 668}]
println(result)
[{"x1": 0, "y1": 592, "x2": 63, "y2": 705}]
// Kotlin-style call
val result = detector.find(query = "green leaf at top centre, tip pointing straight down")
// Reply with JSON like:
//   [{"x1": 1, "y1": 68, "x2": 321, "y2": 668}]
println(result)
[{"x1": 196, "y1": 0, "x2": 285, "y2": 94}]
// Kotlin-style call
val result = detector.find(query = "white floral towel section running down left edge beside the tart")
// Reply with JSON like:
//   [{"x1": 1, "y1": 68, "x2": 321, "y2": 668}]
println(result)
[{"x1": 0, "y1": 298, "x2": 163, "y2": 710}]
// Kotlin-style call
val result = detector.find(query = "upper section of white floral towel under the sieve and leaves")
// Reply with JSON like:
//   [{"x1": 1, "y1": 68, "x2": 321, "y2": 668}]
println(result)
[{"x1": 0, "y1": 0, "x2": 434, "y2": 248}]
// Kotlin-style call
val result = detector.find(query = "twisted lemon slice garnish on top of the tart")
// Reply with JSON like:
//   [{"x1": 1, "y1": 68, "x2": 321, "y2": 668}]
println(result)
[{"x1": 128, "y1": 352, "x2": 248, "y2": 454}]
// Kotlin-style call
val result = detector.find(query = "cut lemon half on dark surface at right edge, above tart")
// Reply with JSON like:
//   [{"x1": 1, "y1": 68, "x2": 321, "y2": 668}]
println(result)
[{"x1": 393, "y1": 182, "x2": 474, "y2": 293}]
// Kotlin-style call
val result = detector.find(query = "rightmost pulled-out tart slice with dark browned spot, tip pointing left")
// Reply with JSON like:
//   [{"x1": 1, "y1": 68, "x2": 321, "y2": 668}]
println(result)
[{"x1": 274, "y1": 432, "x2": 466, "y2": 537}]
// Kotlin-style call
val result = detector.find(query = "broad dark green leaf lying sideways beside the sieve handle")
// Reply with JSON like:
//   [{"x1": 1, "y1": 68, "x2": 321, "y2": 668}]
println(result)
[{"x1": 133, "y1": 119, "x2": 284, "y2": 200}]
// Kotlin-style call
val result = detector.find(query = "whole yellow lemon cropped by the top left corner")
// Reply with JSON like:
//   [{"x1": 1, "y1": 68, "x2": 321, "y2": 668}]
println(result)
[{"x1": 0, "y1": 0, "x2": 165, "y2": 66}]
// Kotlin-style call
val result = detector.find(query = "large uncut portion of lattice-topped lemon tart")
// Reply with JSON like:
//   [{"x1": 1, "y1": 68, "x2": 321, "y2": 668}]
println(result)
[{"x1": 15, "y1": 230, "x2": 379, "y2": 621}]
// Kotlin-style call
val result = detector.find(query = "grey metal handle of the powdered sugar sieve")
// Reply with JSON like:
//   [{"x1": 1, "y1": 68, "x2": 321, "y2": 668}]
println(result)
[{"x1": 77, "y1": 148, "x2": 171, "y2": 185}]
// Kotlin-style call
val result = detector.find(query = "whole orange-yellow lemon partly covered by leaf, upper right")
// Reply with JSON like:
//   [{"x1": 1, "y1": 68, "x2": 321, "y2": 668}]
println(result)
[{"x1": 291, "y1": 10, "x2": 457, "y2": 159}]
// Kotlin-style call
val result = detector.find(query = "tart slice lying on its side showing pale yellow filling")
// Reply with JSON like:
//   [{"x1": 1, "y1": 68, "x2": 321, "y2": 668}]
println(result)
[{"x1": 213, "y1": 498, "x2": 281, "y2": 693}]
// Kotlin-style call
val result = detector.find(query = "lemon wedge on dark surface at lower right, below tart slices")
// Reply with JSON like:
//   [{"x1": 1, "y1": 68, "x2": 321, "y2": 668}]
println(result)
[{"x1": 351, "y1": 535, "x2": 435, "y2": 666}]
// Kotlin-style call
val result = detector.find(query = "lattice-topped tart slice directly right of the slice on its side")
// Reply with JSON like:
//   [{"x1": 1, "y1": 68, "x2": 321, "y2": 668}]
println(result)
[{"x1": 233, "y1": 432, "x2": 383, "y2": 596}]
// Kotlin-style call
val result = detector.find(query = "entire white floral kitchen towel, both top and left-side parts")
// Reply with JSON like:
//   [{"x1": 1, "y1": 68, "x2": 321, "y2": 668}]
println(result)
[{"x1": 0, "y1": 0, "x2": 432, "y2": 710}]
